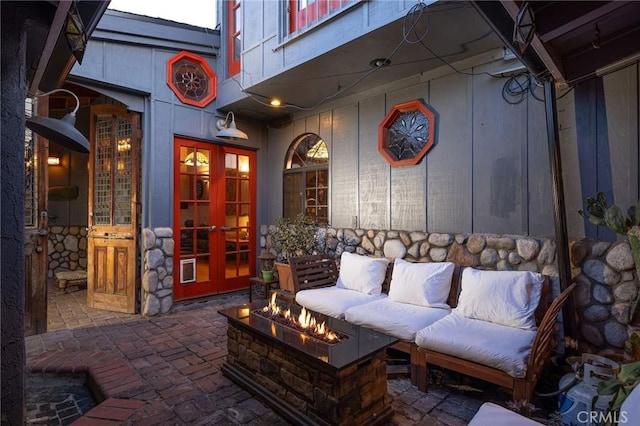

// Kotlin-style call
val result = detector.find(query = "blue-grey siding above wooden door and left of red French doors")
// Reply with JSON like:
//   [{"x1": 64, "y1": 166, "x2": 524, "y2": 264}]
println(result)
[{"x1": 70, "y1": 10, "x2": 263, "y2": 228}]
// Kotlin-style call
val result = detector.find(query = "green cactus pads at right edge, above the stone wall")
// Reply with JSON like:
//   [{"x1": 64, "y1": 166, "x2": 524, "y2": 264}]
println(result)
[{"x1": 578, "y1": 192, "x2": 640, "y2": 235}]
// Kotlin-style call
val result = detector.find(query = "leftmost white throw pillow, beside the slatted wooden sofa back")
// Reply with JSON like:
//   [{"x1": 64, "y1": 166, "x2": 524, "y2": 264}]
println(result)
[{"x1": 336, "y1": 252, "x2": 389, "y2": 296}]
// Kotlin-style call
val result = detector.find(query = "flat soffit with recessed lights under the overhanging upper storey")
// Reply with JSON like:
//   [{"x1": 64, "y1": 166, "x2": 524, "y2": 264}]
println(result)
[{"x1": 225, "y1": 2, "x2": 503, "y2": 125}]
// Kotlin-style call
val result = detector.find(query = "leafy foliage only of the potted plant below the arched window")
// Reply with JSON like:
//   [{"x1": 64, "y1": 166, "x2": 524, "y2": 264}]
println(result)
[{"x1": 269, "y1": 214, "x2": 324, "y2": 260}]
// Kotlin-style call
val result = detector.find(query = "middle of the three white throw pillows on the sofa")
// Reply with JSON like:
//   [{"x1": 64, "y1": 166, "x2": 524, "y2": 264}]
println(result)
[{"x1": 389, "y1": 258, "x2": 455, "y2": 308}]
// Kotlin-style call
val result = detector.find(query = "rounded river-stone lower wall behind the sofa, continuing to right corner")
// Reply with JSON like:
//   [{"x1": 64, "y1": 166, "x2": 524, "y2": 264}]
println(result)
[{"x1": 260, "y1": 225, "x2": 638, "y2": 355}]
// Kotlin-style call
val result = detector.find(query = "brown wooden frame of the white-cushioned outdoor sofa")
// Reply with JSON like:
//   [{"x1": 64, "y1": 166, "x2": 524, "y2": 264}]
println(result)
[{"x1": 289, "y1": 254, "x2": 576, "y2": 401}]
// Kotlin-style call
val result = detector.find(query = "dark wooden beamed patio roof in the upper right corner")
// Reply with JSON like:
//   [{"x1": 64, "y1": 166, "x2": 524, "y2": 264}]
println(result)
[{"x1": 473, "y1": 0, "x2": 640, "y2": 86}]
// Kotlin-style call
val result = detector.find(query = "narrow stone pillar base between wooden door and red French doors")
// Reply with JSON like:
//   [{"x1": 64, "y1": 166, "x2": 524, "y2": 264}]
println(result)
[{"x1": 141, "y1": 228, "x2": 174, "y2": 316}]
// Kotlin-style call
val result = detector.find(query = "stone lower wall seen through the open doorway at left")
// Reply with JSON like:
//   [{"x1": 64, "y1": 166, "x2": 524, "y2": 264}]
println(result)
[{"x1": 47, "y1": 226, "x2": 87, "y2": 278}]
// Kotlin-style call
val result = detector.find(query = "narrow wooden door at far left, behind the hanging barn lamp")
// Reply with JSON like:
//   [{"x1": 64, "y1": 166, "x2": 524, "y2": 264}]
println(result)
[{"x1": 24, "y1": 98, "x2": 49, "y2": 336}]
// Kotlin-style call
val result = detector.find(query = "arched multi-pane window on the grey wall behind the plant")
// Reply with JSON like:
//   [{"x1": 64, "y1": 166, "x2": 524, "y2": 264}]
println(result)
[{"x1": 282, "y1": 133, "x2": 329, "y2": 224}]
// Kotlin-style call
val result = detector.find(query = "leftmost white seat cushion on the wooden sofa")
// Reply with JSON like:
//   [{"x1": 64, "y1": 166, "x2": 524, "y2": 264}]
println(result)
[{"x1": 296, "y1": 286, "x2": 387, "y2": 319}]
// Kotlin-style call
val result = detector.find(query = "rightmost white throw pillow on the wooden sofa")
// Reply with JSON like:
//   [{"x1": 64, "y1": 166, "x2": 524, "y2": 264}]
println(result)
[{"x1": 454, "y1": 268, "x2": 544, "y2": 330}]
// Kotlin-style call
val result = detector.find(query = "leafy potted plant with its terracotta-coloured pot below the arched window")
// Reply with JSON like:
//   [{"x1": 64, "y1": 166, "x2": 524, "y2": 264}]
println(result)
[{"x1": 268, "y1": 214, "x2": 324, "y2": 293}]
